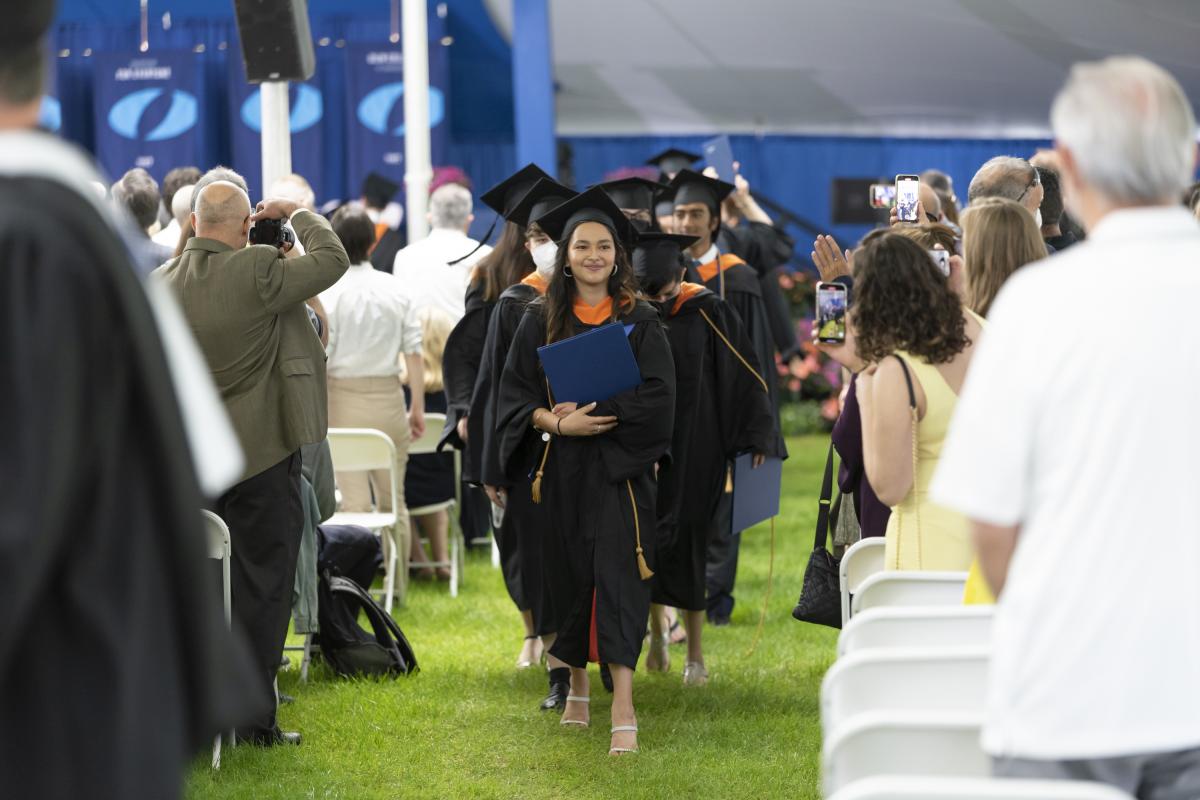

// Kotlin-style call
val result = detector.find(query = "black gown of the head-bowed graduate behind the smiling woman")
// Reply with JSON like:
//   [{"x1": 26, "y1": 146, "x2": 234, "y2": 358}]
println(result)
[{"x1": 653, "y1": 291, "x2": 776, "y2": 610}]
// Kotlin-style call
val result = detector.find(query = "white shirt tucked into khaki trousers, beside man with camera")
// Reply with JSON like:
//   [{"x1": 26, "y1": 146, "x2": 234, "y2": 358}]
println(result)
[{"x1": 320, "y1": 261, "x2": 421, "y2": 378}]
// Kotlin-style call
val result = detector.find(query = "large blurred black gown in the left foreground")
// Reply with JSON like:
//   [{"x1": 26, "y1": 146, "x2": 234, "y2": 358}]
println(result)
[{"x1": 0, "y1": 170, "x2": 266, "y2": 798}]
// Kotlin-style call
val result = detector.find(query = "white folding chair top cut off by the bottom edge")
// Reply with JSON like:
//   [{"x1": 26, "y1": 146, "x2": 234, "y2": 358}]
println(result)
[{"x1": 829, "y1": 775, "x2": 1134, "y2": 800}]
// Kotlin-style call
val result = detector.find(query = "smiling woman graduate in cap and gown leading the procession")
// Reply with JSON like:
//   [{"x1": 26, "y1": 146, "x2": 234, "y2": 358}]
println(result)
[{"x1": 498, "y1": 187, "x2": 674, "y2": 754}]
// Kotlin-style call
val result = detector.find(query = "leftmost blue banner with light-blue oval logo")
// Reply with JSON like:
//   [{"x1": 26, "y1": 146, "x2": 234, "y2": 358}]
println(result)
[{"x1": 95, "y1": 50, "x2": 202, "y2": 181}]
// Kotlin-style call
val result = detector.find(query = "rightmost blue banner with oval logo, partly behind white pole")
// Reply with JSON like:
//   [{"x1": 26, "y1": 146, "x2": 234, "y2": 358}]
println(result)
[{"x1": 346, "y1": 43, "x2": 449, "y2": 205}]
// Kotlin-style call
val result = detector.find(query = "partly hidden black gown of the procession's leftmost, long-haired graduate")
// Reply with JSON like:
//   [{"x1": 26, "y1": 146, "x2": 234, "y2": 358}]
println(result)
[{"x1": 438, "y1": 283, "x2": 496, "y2": 485}]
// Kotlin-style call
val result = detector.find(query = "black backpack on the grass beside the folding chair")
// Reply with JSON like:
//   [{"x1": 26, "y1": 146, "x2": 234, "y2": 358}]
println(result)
[{"x1": 313, "y1": 525, "x2": 418, "y2": 678}]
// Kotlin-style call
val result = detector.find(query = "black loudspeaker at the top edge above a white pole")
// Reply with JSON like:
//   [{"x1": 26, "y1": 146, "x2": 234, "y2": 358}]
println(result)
[{"x1": 233, "y1": 0, "x2": 317, "y2": 83}]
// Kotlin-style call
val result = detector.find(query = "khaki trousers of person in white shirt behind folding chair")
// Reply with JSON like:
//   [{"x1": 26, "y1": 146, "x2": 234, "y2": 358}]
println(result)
[{"x1": 328, "y1": 375, "x2": 412, "y2": 604}]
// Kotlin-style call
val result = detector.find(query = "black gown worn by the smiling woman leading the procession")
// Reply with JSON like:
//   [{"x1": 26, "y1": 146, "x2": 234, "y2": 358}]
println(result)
[{"x1": 497, "y1": 302, "x2": 674, "y2": 669}]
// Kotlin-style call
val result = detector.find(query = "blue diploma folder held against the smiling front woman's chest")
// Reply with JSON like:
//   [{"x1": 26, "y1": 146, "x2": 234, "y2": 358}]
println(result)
[{"x1": 538, "y1": 323, "x2": 642, "y2": 405}]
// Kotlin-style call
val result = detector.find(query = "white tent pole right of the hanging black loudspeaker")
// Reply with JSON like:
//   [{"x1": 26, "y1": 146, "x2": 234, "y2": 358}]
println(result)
[{"x1": 402, "y1": 0, "x2": 433, "y2": 242}]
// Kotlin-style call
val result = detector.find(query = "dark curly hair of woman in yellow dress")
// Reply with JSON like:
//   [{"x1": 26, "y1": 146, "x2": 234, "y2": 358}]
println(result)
[{"x1": 851, "y1": 231, "x2": 971, "y2": 363}]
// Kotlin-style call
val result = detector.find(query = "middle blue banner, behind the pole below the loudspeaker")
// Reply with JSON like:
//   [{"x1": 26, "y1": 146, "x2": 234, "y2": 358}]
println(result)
[{"x1": 229, "y1": 66, "x2": 329, "y2": 201}]
